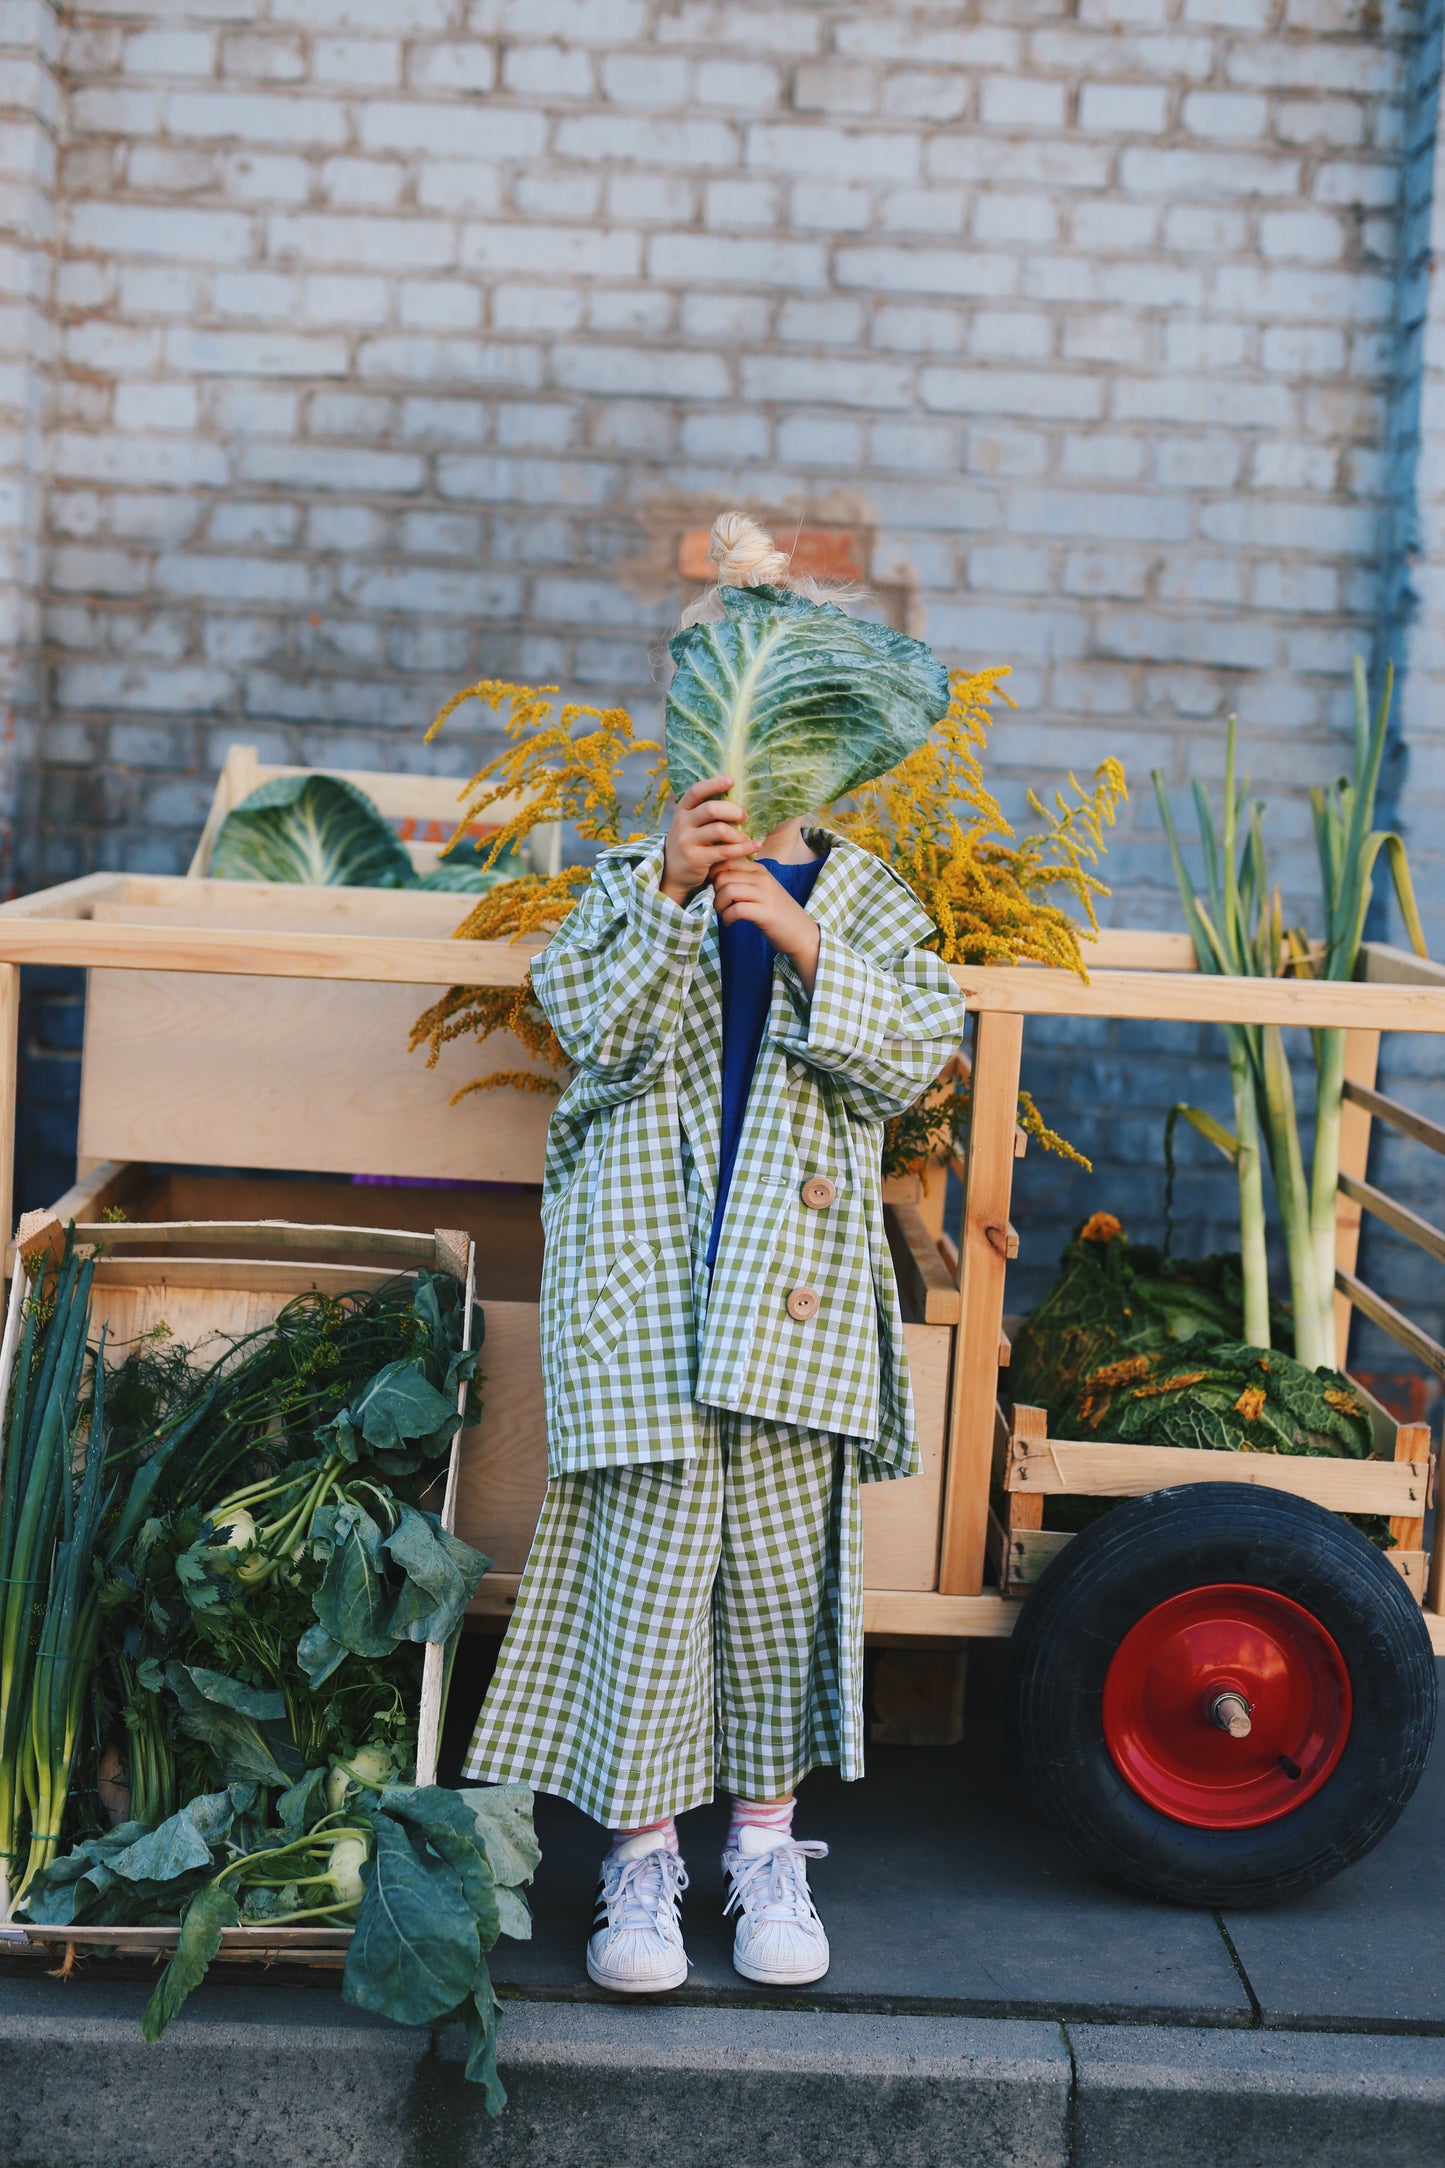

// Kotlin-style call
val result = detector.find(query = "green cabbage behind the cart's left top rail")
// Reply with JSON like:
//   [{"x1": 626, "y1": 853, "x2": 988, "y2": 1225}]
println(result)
[{"x1": 210, "y1": 774, "x2": 416, "y2": 889}]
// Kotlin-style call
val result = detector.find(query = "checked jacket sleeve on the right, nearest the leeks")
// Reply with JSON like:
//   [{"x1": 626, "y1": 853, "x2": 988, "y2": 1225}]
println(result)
[{"x1": 778, "y1": 928, "x2": 966, "y2": 1121}]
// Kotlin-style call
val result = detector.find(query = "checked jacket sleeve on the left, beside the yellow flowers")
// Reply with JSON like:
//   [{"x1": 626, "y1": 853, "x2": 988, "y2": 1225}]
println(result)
[{"x1": 531, "y1": 837, "x2": 713, "y2": 1104}]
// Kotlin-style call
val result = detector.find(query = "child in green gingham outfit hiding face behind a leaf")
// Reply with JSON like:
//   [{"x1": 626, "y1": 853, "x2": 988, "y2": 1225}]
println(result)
[{"x1": 468, "y1": 514, "x2": 964, "y2": 1992}]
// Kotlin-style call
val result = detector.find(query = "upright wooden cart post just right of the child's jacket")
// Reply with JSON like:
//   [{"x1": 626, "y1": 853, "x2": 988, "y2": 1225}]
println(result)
[{"x1": 938, "y1": 1015, "x2": 1023, "y2": 1596}]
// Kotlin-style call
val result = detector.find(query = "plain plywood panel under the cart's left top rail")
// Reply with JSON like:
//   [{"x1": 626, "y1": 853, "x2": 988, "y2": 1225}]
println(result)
[{"x1": 78, "y1": 971, "x2": 555, "y2": 1182}]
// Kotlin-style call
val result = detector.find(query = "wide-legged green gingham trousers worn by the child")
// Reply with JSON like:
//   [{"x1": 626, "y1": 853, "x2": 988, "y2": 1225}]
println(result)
[{"x1": 466, "y1": 1407, "x2": 862, "y2": 1830}]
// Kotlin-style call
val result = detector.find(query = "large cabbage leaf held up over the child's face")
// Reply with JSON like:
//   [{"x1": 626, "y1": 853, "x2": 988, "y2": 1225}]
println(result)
[{"x1": 667, "y1": 588, "x2": 949, "y2": 839}]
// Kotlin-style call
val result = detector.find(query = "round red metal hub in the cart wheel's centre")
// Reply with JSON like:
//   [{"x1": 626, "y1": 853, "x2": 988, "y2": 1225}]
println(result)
[{"x1": 1103, "y1": 1583, "x2": 1352, "y2": 1830}]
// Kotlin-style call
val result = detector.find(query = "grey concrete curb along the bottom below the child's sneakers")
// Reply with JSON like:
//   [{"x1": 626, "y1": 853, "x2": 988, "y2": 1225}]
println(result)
[{"x1": 0, "y1": 1979, "x2": 1445, "y2": 2168}]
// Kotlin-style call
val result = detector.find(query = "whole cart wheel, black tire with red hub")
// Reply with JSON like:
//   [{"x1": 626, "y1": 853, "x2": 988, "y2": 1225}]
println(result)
[{"x1": 1012, "y1": 1483, "x2": 1436, "y2": 1906}]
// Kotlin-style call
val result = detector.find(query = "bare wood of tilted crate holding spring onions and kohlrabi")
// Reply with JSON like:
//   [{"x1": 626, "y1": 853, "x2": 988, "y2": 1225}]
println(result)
[{"x1": 0, "y1": 1212, "x2": 477, "y2": 1964}]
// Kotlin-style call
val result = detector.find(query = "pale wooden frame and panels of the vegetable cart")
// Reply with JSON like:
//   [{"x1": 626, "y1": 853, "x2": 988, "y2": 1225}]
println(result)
[{"x1": 0, "y1": 874, "x2": 1445, "y2": 1650}]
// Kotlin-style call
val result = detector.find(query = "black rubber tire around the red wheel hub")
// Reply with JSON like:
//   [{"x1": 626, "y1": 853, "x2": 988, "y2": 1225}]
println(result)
[{"x1": 1010, "y1": 1483, "x2": 1436, "y2": 1906}]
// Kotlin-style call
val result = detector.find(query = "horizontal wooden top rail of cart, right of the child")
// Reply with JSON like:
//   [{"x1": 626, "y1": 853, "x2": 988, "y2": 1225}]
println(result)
[{"x1": 951, "y1": 963, "x2": 1445, "y2": 1032}]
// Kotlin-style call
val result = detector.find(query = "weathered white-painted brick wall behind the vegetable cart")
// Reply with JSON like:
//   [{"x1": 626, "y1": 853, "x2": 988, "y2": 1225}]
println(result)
[{"x1": 14, "y1": 0, "x2": 1445, "y2": 1352}]
